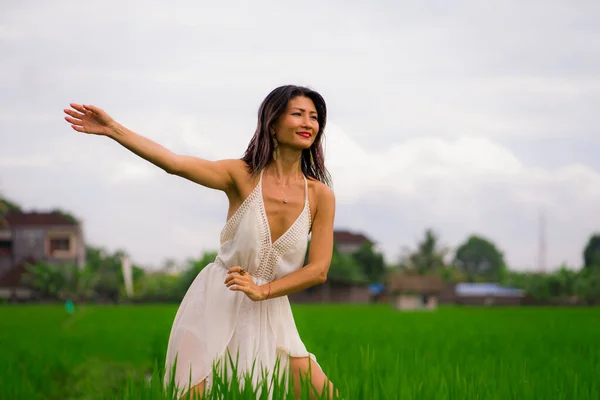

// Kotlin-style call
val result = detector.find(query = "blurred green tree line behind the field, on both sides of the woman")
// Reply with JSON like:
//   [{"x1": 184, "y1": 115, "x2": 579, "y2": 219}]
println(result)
[{"x1": 0, "y1": 194, "x2": 600, "y2": 304}]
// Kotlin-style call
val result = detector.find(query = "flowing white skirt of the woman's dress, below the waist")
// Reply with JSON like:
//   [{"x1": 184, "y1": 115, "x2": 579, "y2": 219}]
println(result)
[{"x1": 165, "y1": 263, "x2": 316, "y2": 393}]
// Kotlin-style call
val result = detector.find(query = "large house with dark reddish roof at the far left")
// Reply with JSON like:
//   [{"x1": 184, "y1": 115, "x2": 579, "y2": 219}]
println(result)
[{"x1": 0, "y1": 211, "x2": 85, "y2": 297}]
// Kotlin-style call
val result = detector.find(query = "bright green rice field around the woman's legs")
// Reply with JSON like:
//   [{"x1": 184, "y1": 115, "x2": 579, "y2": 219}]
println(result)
[{"x1": 0, "y1": 305, "x2": 600, "y2": 400}]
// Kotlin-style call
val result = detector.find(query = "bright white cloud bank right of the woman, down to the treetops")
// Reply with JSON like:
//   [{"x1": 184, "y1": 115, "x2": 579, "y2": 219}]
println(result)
[{"x1": 327, "y1": 126, "x2": 600, "y2": 268}]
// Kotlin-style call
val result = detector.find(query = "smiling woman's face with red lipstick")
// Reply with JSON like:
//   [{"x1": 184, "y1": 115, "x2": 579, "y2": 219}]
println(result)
[{"x1": 273, "y1": 96, "x2": 319, "y2": 150}]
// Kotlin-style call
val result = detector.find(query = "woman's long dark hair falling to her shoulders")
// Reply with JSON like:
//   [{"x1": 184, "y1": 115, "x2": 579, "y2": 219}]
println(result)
[{"x1": 242, "y1": 85, "x2": 331, "y2": 186}]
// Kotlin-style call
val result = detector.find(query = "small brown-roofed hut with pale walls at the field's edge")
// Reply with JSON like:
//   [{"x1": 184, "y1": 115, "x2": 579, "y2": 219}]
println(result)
[{"x1": 387, "y1": 272, "x2": 446, "y2": 310}]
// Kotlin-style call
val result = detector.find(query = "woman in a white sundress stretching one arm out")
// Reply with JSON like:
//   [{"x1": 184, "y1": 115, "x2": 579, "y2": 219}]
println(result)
[{"x1": 65, "y1": 86, "x2": 335, "y2": 395}]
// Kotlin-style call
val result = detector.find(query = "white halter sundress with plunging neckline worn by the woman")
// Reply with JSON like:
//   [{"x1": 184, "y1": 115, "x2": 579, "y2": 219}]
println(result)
[{"x1": 165, "y1": 171, "x2": 318, "y2": 393}]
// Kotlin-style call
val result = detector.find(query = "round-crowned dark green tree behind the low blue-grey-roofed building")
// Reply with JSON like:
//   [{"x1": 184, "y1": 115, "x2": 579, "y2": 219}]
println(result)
[{"x1": 454, "y1": 235, "x2": 504, "y2": 282}]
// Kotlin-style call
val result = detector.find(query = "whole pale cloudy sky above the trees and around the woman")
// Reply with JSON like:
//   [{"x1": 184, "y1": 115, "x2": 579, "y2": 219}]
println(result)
[{"x1": 0, "y1": 0, "x2": 600, "y2": 270}]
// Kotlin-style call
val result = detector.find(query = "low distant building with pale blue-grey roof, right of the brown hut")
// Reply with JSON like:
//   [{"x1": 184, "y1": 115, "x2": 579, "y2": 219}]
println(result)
[{"x1": 454, "y1": 283, "x2": 525, "y2": 306}]
